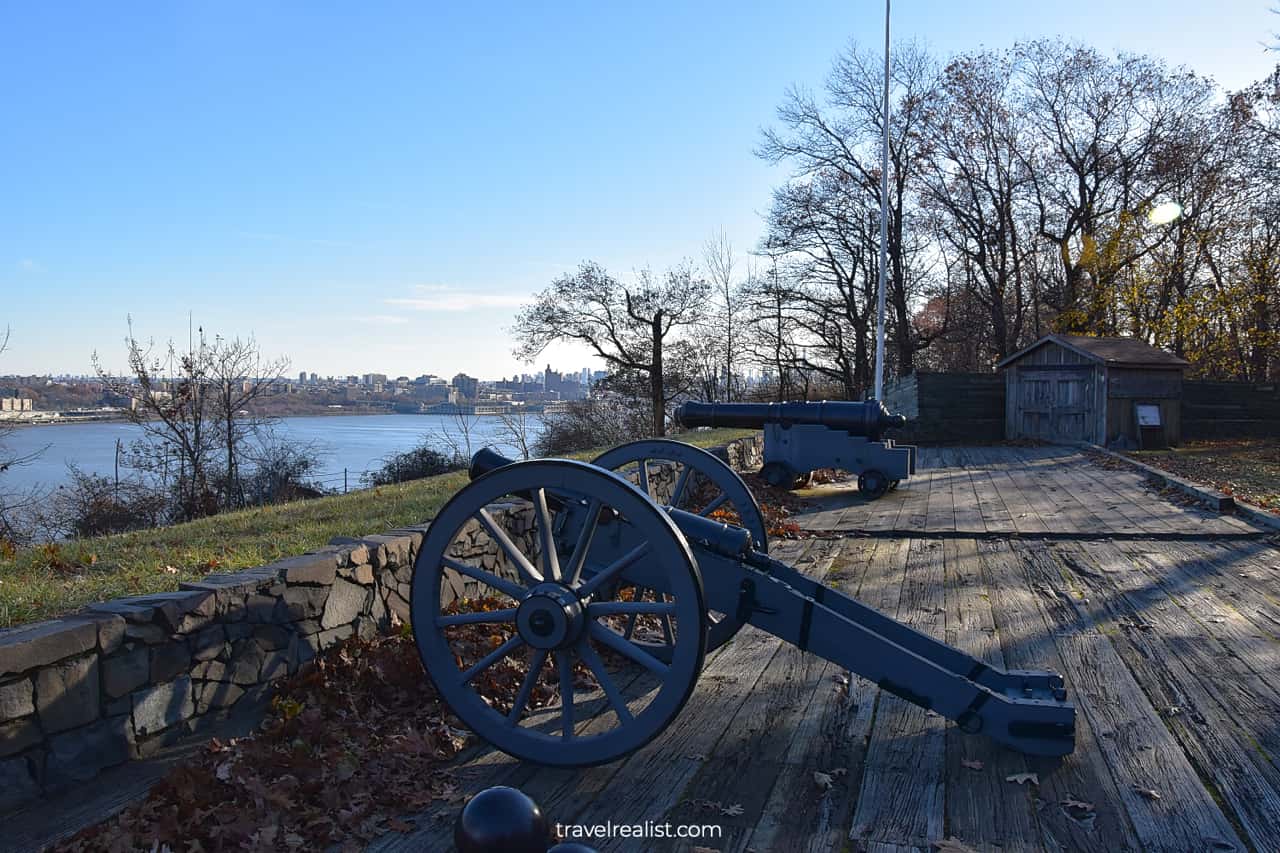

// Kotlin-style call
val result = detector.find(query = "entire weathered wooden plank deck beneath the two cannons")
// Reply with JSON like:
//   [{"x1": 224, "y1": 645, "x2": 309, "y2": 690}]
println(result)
[{"x1": 370, "y1": 447, "x2": 1280, "y2": 853}]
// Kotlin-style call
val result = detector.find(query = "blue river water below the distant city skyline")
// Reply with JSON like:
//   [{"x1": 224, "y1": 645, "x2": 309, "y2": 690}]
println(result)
[{"x1": 0, "y1": 415, "x2": 541, "y2": 493}]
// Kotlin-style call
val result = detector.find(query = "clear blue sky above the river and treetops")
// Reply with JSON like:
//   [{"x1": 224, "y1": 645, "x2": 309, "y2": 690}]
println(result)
[{"x1": 0, "y1": 0, "x2": 1280, "y2": 378}]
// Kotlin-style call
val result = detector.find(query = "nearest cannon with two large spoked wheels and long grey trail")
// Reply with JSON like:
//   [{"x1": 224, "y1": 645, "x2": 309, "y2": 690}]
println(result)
[{"x1": 411, "y1": 441, "x2": 1075, "y2": 766}]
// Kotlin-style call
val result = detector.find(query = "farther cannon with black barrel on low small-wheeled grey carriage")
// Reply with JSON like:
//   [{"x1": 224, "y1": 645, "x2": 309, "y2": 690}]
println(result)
[{"x1": 676, "y1": 400, "x2": 915, "y2": 500}]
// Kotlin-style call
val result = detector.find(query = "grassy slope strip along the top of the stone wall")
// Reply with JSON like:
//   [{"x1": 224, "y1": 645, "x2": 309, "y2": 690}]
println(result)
[{"x1": 0, "y1": 429, "x2": 751, "y2": 628}]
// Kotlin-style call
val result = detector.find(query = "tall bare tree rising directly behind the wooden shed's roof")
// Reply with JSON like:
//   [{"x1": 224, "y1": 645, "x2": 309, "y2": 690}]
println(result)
[{"x1": 1014, "y1": 41, "x2": 1212, "y2": 333}]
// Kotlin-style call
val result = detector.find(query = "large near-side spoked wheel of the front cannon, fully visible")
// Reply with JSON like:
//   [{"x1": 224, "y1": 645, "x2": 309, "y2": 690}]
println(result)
[{"x1": 410, "y1": 460, "x2": 707, "y2": 766}]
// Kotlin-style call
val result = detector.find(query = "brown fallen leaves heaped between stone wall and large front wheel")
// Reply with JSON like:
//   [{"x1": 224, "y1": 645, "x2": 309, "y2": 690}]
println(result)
[{"x1": 52, "y1": 602, "x2": 524, "y2": 852}]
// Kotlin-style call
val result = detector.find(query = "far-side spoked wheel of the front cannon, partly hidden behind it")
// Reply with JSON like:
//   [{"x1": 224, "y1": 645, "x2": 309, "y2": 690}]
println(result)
[{"x1": 591, "y1": 438, "x2": 769, "y2": 657}]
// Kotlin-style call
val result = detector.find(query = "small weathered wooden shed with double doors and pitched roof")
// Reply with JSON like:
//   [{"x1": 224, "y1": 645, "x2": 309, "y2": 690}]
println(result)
[{"x1": 997, "y1": 334, "x2": 1188, "y2": 447}]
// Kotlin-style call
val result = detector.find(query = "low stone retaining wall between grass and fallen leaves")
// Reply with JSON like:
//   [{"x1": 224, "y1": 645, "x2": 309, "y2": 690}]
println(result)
[{"x1": 0, "y1": 437, "x2": 760, "y2": 812}]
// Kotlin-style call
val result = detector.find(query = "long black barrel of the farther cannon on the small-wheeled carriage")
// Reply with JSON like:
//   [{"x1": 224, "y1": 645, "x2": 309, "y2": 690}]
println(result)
[{"x1": 676, "y1": 400, "x2": 906, "y2": 439}]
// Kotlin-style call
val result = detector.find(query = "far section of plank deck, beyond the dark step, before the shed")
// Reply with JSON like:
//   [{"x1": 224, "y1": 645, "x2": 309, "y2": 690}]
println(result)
[{"x1": 799, "y1": 446, "x2": 1266, "y2": 538}]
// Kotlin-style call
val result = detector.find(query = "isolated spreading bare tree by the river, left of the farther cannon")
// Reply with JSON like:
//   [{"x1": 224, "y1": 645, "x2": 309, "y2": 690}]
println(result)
[{"x1": 512, "y1": 261, "x2": 708, "y2": 435}]
